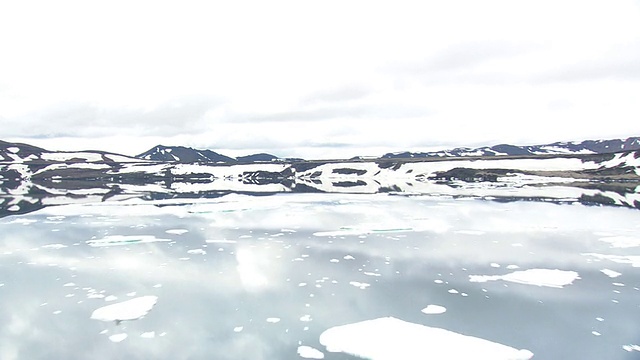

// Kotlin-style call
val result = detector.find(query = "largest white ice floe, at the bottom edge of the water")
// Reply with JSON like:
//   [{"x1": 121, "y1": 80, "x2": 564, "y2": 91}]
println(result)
[{"x1": 320, "y1": 317, "x2": 533, "y2": 360}]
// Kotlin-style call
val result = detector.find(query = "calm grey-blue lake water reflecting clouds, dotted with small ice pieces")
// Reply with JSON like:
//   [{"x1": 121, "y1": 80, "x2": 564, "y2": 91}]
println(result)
[{"x1": 0, "y1": 194, "x2": 640, "y2": 360}]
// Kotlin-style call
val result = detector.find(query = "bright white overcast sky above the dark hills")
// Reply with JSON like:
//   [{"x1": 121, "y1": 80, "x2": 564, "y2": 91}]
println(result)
[{"x1": 0, "y1": 0, "x2": 640, "y2": 158}]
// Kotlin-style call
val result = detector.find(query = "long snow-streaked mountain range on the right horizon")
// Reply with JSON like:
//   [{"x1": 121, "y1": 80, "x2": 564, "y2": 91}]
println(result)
[{"x1": 382, "y1": 137, "x2": 640, "y2": 159}]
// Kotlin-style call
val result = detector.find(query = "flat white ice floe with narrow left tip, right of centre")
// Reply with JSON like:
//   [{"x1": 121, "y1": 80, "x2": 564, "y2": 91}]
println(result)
[{"x1": 469, "y1": 269, "x2": 580, "y2": 288}]
